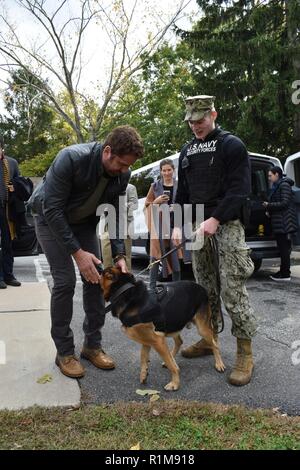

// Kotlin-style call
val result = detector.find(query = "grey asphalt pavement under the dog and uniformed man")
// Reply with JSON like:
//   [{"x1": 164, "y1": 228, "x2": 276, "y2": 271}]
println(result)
[{"x1": 15, "y1": 257, "x2": 300, "y2": 415}]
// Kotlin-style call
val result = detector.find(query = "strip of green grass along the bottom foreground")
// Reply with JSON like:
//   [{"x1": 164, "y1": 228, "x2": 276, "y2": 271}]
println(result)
[{"x1": 0, "y1": 401, "x2": 300, "y2": 450}]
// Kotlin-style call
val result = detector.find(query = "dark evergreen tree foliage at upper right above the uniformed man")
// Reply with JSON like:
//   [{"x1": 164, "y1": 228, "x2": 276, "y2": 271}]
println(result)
[{"x1": 178, "y1": 0, "x2": 300, "y2": 156}]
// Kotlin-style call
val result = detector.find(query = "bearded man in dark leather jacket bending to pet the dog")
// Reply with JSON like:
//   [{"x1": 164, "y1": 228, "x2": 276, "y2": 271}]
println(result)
[{"x1": 29, "y1": 126, "x2": 144, "y2": 377}]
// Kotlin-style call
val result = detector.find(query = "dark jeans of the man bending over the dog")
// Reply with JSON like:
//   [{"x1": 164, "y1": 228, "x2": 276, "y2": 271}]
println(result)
[{"x1": 35, "y1": 217, "x2": 105, "y2": 356}]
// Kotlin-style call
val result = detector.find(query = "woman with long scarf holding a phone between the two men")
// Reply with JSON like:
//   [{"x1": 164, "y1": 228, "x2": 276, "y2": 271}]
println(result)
[{"x1": 144, "y1": 159, "x2": 189, "y2": 292}]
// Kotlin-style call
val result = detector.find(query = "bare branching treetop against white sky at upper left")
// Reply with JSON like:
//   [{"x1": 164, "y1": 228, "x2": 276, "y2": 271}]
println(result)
[{"x1": 0, "y1": 0, "x2": 191, "y2": 142}]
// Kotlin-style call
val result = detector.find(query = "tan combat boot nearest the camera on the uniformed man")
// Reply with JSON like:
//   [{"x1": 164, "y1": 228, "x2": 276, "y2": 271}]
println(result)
[{"x1": 229, "y1": 338, "x2": 254, "y2": 385}]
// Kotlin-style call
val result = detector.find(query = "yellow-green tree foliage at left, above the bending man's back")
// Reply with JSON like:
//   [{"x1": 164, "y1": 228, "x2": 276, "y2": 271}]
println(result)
[{"x1": 0, "y1": 70, "x2": 76, "y2": 176}]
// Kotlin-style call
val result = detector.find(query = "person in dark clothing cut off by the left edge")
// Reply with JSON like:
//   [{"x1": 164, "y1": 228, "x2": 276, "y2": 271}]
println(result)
[{"x1": 0, "y1": 138, "x2": 21, "y2": 289}]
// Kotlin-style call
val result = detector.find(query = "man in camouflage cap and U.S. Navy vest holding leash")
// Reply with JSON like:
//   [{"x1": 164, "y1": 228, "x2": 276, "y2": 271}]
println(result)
[{"x1": 173, "y1": 95, "x2": 257, "y2": 385}]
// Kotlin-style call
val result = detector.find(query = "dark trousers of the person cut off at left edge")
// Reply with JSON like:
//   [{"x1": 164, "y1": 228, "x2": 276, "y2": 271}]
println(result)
[{"x1": 0, "y1": 201, "x2": 14, "y2": 281}]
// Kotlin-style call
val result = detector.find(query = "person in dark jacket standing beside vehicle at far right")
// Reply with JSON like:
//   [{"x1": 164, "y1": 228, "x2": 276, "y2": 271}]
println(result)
[{"x1": 263, "y1": 166, "x2": 298, "y2": 281}]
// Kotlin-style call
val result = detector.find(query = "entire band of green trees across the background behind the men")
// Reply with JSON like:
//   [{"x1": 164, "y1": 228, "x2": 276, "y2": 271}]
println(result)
[{"x1": 0, "y1": 0, "x2": 300, "y2": 176}]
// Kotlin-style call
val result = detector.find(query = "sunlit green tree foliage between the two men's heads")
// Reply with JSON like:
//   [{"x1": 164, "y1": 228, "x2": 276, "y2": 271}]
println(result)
[{"x1": 99, "y1": 44, "x2": 195, "y2": 168}]
